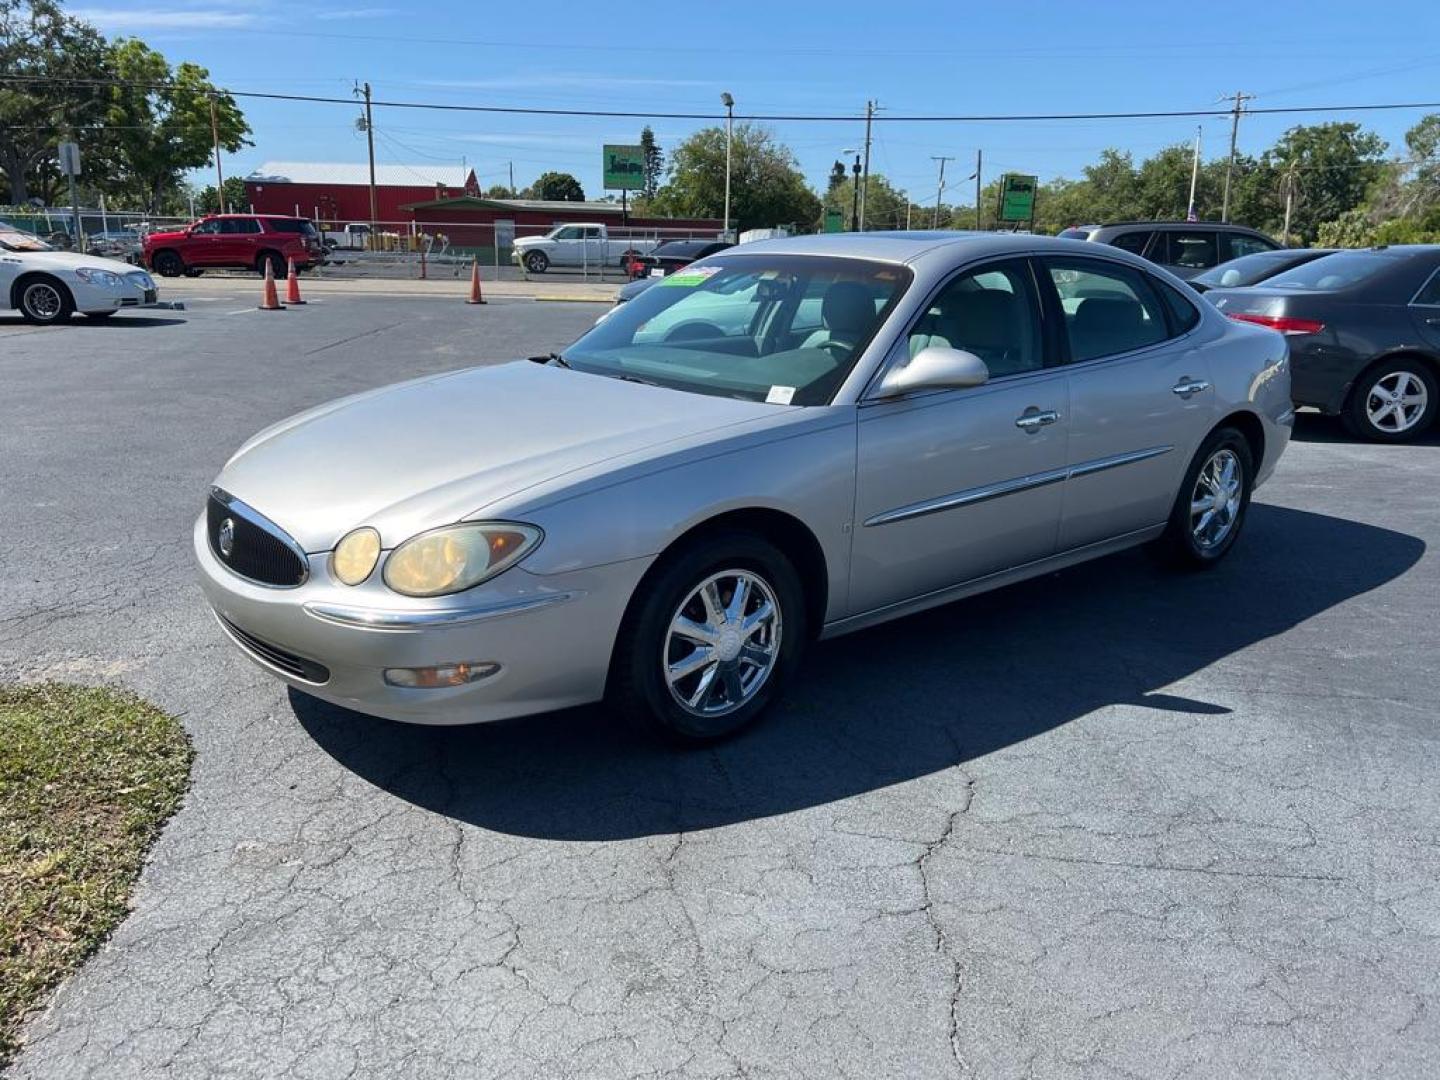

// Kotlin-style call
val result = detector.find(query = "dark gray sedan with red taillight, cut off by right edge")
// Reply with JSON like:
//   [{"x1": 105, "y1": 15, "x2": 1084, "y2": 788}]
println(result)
[{"x1": 1205, "y1": 245, "x2": 1440, "y2": 442}]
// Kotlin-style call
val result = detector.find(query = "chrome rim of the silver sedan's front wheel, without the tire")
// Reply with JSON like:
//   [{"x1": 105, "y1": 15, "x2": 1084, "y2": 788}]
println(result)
[{"x1": 661, "y1": 570, "x2": 780, "y2": 717}]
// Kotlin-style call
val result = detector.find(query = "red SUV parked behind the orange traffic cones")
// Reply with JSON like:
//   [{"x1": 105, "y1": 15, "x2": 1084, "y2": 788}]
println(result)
[{"x1": 141, "y1": 213, "x2": 325, "y2": 278}]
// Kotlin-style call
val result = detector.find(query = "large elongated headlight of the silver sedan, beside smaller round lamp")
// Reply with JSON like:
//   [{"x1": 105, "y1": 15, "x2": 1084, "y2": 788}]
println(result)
[{"x1": 384, "y1": 521, "x2": 543, "y2": 596}]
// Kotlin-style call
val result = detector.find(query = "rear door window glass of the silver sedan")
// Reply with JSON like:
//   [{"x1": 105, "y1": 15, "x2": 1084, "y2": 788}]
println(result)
[{"x1": 1045, "y1": 259, "x2": 1169, "y2": 363}]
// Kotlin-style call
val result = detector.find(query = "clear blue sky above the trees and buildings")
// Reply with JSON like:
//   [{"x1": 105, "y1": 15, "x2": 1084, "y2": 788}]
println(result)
[{"x1": 71, "y1": 0, "x2": 1440, "y2": 202}]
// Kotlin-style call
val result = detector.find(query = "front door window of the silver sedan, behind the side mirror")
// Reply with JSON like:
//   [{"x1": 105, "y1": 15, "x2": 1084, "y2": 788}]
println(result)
[{"x1": 909, "y1": 261, "x2": 1045, "y2": 379}]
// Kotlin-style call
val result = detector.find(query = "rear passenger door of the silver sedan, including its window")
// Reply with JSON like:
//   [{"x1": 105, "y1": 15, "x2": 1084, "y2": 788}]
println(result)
[{"x1": 1040, "y1": 258, "x2": 1215, "y2": 552}]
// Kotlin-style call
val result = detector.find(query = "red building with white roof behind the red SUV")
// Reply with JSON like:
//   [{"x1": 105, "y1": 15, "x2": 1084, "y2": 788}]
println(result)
[{"x1": 245, "y1": 161, "x2": 480, "y2": 225}]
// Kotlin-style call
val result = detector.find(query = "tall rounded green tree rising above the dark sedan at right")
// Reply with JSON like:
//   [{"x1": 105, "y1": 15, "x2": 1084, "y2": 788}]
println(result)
[{"x1": 1261, "y1": 122, "x2": 1387, "y2": 243}]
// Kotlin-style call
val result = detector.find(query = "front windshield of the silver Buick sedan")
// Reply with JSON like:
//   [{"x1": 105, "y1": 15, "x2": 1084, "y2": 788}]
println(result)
[{"x1": 564, "y1": 255, "x2": 912, "y2": 405}]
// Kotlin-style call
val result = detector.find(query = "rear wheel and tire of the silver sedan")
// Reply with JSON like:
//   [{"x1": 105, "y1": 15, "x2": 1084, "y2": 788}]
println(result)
[{"x1": 1153, "y1": 428, "x2": 1256, "y2": 570}]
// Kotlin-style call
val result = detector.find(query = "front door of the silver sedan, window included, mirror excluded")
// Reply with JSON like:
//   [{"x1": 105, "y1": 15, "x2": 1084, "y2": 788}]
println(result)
[{"x1": 850, "y1": 259, "x2": 1070, "y2": 615}]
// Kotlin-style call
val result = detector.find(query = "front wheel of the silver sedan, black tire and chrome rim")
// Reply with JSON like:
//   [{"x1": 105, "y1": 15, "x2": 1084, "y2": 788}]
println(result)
[{"x1": 609, "y1": 533, "x2": 808, "y2": 743}]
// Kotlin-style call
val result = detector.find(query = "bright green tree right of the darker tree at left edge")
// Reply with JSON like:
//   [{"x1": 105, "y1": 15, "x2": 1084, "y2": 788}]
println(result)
[{"x1": 105, "y1": 37, "x2": 251, "y2": 213}]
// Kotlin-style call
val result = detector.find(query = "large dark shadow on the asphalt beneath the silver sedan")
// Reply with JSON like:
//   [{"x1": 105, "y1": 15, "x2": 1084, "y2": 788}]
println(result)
[{"x1": 291, "y1": 504, "x2": 1426, "y2": 841}]
